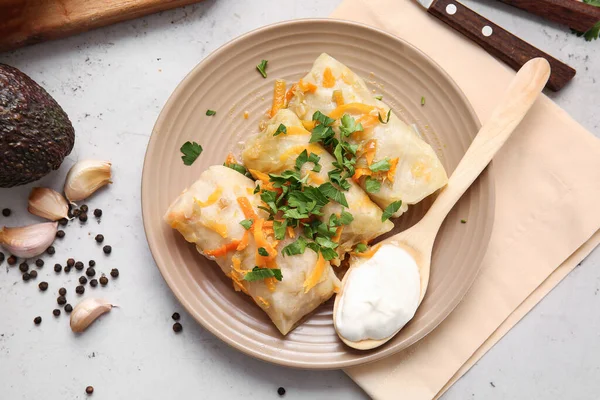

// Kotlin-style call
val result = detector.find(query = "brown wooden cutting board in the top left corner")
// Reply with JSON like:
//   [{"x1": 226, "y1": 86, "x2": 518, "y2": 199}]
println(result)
[{"x1": 0, "y1": 0, "x2": 200, "y2": 52}]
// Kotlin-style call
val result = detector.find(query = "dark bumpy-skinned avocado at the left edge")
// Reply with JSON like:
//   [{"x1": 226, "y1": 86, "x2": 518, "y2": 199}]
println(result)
[{"x1": 0, "y1": 64, "x2": 75, "y2": 187}]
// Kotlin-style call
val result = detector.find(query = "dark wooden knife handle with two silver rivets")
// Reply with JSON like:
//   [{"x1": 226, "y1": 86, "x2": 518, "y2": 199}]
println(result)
[{"x1": 428, "y1": 0, "x2": 576, "y2": 92}]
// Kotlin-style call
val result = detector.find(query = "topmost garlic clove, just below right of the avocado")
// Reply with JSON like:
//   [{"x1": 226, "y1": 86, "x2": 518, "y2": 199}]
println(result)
[{"x1": 65, "y1": 160, "x2": 112, "y2": 202}]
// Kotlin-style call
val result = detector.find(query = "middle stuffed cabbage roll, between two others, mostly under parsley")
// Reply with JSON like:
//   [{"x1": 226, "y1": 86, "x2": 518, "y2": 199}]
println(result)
[{"x1": 242, "y1": 109, "x2": 394, "y2": 265}]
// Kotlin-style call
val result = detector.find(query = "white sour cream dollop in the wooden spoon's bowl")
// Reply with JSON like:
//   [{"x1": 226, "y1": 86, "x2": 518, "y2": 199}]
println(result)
[{"x1": 336, "y1": 244, "x2": 421, "y2": 342}]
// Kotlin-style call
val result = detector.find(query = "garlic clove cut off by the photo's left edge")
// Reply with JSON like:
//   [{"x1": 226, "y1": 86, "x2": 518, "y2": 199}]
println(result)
[{"x1": 0, "y1": 222, "x2": 58, "y2": 258}]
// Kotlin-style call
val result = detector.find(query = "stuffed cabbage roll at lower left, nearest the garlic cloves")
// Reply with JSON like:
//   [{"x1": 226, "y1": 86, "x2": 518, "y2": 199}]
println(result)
[{"x1": 164, "y1": 166, "x2": 340, "y2": 335}]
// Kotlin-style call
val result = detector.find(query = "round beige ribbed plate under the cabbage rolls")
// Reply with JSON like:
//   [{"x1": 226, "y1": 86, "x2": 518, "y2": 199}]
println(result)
[{"x1": 142, "y1": 19, "x2": 494, "y2": 369}]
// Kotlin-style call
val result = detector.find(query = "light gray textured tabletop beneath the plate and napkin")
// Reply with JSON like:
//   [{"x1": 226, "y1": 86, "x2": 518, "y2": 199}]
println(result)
[{"x1": 0, "y1": 0, "x2": 600, "y2": 400}]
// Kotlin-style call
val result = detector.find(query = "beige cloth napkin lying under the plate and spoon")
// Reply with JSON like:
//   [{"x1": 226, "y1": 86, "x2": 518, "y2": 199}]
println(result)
[{"x1": 332, "y1": 0, "x2": 600, "y2": 400}]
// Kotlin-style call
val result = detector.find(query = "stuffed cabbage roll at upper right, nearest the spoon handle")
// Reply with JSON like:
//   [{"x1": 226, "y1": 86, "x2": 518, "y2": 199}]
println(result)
[{"x1": 289, "y1": 54, "x2": 448, "y2": 217}]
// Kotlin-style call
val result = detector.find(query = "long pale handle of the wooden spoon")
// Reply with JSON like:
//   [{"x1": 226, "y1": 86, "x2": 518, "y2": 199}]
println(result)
[{"x1": 423, "y1": 58, "x2": 550, "y2": 232}]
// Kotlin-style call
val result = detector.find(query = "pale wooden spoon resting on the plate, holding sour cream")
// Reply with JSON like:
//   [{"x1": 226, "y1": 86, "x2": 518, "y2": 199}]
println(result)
[{"x1": 333, "y1": 58, "x2": 550, "y2": 350}]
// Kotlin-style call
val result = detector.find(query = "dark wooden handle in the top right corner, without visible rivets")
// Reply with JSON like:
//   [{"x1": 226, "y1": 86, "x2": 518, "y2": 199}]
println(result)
[{"x1": 492, "y1": 0, "x2": 600, "y2": 32}]
